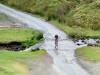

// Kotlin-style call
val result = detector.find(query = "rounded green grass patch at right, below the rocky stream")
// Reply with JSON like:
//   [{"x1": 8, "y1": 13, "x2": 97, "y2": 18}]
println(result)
[{"x1": 76, "y1": 47, "x2": 100, "y2": 61}]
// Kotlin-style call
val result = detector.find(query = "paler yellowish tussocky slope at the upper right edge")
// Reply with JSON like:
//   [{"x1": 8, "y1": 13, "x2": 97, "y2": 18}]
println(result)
[{"x1": 70, "y1": 0, "x2": 100, "y2": 30}]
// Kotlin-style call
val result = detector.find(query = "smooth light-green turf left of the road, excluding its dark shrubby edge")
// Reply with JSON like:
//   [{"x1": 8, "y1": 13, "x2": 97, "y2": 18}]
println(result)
[{"x1": 0, "y1": 28, "x2": 39, "y2": 43}]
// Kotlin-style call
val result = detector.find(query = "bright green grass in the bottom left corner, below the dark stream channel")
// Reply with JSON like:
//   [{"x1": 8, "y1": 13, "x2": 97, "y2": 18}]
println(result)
[{"x1": 0, "y1": 50, "x2": 45, "y2": 75}]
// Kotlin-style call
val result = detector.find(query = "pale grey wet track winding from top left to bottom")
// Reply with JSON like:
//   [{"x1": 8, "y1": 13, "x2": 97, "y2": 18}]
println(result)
[{"x1": 0, "y1": 4, "x2": 89, "y2": 75}]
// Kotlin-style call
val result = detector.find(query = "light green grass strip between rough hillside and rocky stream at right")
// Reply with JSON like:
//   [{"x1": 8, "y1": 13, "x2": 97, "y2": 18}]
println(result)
[{"x1": 50, "y1": 20, "x2": 100, "y2": 39}]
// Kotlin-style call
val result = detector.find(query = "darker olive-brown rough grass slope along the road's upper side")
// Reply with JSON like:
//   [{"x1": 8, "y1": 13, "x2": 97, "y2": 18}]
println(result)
[{"x1": 0, "y1": 0, "x2": 77, "y2": 22}]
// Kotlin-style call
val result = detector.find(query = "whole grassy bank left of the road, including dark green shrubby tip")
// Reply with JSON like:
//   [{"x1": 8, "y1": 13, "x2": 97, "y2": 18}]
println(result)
[{"x1": 0, "y1": 28, "x2": 43, "y2": 49}]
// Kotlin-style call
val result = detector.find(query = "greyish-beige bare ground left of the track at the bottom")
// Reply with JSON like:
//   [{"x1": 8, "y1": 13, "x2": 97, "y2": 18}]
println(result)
[{"x1": 17, "y1": 53, "x2": 60, "y2": 75}]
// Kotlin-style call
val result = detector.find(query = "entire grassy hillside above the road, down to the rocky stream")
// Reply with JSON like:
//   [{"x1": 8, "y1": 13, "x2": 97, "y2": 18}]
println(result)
[{"x1": 0, "y1": 0, "x2": 100, "y2": 38}]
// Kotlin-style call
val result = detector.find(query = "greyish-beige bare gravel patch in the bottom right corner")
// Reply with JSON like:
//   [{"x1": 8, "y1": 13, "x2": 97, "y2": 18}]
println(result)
[{"x1": 77, "y1": 56, "x2": 100, "y2": 75}]
